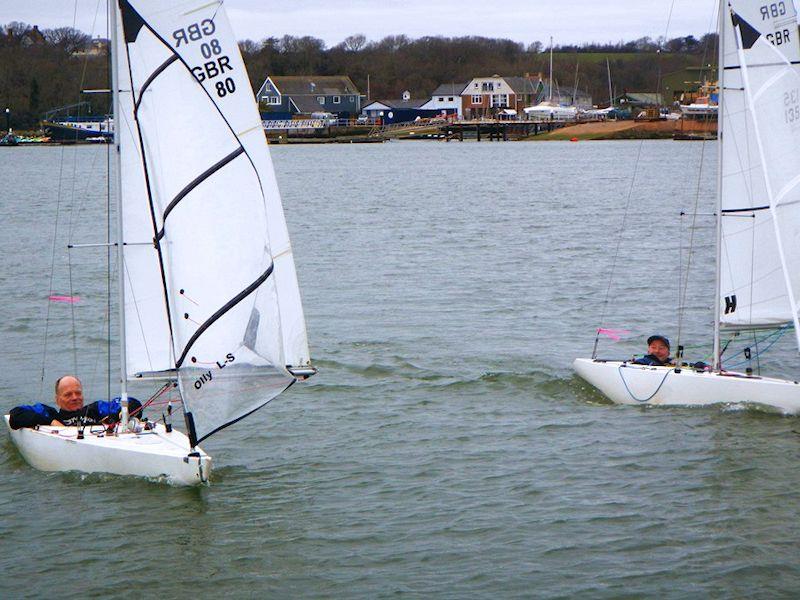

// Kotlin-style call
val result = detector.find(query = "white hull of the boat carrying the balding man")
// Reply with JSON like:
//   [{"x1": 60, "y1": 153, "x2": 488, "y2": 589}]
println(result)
[{"x1": 5, "y1": 415, "x2": 211, "y2": 485}]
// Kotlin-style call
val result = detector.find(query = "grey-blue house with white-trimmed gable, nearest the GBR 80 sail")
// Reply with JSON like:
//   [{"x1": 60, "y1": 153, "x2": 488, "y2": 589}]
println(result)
[{"x1": 256, "y1": 75, "x2": 362, "y2": 119}]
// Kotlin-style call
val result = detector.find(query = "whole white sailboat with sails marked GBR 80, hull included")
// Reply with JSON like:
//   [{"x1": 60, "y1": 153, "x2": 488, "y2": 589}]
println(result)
[{"x1": 6, "y1": 0, "x2": 316, "y2": 484}]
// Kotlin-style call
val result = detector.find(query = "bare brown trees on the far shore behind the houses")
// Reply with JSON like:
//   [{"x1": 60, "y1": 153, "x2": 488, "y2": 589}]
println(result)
[{"x1": 0, "y1": 22, "x2": 717, "y2": 129}]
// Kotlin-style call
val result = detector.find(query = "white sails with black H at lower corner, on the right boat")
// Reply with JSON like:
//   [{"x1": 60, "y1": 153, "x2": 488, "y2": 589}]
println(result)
[{"x1": 719, "y1": 0, "x2": 800, "y2": 338}]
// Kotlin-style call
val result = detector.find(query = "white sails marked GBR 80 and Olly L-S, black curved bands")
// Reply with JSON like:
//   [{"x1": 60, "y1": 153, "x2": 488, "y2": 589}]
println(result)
[{"x1": 117, "y1": 0, "x2": 310, "y2": 443}]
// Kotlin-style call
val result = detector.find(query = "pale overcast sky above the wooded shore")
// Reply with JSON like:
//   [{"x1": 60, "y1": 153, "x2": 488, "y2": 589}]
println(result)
[{"x1": 0, "y1": 0, "x2": 717, "y2": 46}]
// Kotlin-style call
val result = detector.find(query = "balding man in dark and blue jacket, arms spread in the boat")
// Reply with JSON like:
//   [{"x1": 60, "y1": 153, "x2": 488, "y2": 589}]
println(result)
[{"x1": 9, "y1": 375, "x2": 142, "y2": 429}]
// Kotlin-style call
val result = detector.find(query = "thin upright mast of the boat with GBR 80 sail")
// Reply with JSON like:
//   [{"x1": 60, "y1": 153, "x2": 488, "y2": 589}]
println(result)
[{"x1": 108, "y1": 0, "x2": 128, "y2": 431}]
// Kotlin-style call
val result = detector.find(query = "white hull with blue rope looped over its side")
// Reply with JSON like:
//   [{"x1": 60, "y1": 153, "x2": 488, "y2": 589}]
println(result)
[{"x1": 573, "y1": 358, "x2": 800, "y2": 414}]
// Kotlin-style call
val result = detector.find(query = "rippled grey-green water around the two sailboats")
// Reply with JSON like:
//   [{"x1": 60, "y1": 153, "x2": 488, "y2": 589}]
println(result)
[{"x1": 0, "y1": 141, "x2": 800, "y2": 598}]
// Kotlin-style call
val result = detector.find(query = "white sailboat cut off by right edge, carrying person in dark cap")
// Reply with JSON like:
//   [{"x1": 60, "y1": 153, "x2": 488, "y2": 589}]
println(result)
[{"x1": 574, "y1": 0, "x2": 800, "y2": 414}]
